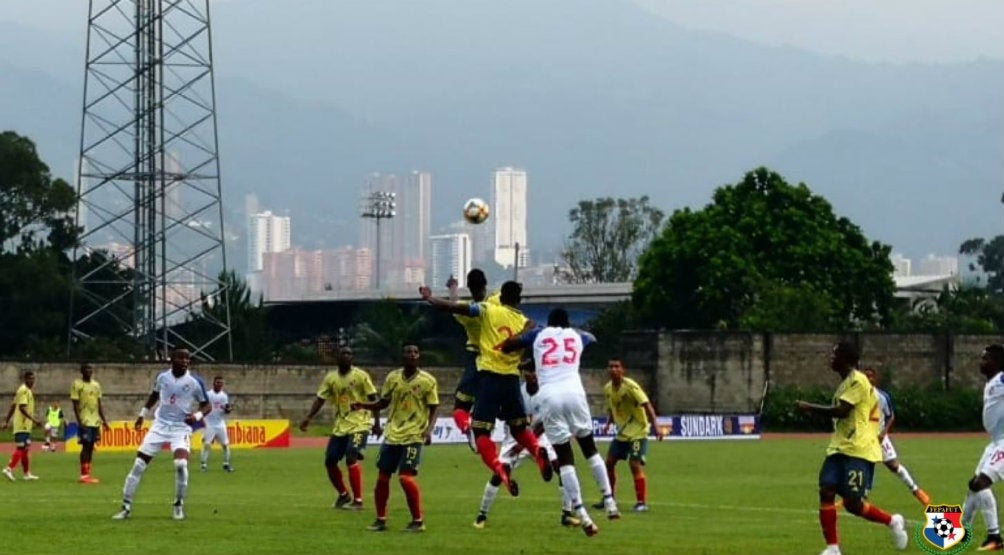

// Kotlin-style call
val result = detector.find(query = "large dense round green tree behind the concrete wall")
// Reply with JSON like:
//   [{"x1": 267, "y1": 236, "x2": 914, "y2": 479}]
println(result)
[{"x1": 632, "y1": 168, "x2": 895, "y2": 329}]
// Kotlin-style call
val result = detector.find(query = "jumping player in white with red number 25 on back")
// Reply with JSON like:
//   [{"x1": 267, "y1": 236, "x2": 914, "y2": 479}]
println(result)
[{"x1": 502, "y1": 308, "x2": 620, "y2": 536}]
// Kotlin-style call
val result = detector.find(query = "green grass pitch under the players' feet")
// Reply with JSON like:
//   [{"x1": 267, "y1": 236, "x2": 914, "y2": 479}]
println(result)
[{"x1": 0, "y1": 436, "x2": 985, "y2": 555}]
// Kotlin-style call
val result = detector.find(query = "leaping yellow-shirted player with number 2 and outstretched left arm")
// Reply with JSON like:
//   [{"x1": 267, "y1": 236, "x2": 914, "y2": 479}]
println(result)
[{"x1": 419, "y1": 281, "x2": 554, "y2": 495}]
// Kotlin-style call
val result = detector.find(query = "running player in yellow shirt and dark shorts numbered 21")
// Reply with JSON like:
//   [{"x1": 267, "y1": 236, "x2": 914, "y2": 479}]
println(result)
[{"x1": 795, "y1": 341, "x2": 909, "y2": 555}]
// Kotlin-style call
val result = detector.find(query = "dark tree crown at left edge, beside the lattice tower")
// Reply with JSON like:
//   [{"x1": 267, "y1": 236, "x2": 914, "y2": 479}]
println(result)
[{"x1": 0, "y1": 131, "x2": 79, "y2": 253}]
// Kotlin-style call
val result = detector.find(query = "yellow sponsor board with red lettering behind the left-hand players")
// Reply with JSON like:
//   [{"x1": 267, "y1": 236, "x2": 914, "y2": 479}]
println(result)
[{"x1": 65, "y1": 419, "x2": 290, "y2": 453}]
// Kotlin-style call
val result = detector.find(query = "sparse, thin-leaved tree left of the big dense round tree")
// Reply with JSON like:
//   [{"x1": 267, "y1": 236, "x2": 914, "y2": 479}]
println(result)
[{"x1": 561, "y1": 197, "x2": 665, "y2": 283}]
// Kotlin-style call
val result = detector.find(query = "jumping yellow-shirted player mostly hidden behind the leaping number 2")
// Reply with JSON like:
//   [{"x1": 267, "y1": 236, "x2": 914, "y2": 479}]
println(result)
[{"x1": 446, "y1": 268, "x2": 498, "y2": 453}]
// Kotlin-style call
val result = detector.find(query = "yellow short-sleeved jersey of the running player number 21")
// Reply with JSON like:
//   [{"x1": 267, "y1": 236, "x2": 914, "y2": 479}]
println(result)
[{"x1": 826, "y1": 369, "x2": 882, "y2": 463}]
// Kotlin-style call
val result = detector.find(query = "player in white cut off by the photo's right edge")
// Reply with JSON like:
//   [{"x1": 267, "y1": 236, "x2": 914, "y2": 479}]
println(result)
[{"x1": 962, "y1": 343, "x2": 1004, "y2": 551}]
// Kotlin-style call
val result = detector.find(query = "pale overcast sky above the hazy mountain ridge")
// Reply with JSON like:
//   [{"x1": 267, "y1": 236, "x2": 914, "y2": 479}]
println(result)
[{"x1": 7, "y1": 0, "x2": 1004, "y2": 62}]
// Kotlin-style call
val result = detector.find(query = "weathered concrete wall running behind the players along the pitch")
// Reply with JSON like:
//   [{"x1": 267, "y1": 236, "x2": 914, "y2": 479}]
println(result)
[{"x1": 0, "y1": 331, "x2": 1000, "y2": 422}]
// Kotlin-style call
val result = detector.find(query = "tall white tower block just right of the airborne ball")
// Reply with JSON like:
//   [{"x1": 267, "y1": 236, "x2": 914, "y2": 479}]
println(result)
[{"x1": 489, "y1": 168, "x2": 530, "y2": 268}]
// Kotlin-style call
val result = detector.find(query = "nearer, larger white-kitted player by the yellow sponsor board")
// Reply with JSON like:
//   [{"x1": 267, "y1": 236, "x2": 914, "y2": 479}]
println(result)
[{"x1": 111, "y1": 349, "x2": 213, "y2": 520}]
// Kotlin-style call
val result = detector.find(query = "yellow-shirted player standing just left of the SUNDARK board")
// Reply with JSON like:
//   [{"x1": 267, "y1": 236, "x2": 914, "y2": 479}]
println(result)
[{"x1": 592, "y1": 358, "x2": 663, "y2": 513}]
